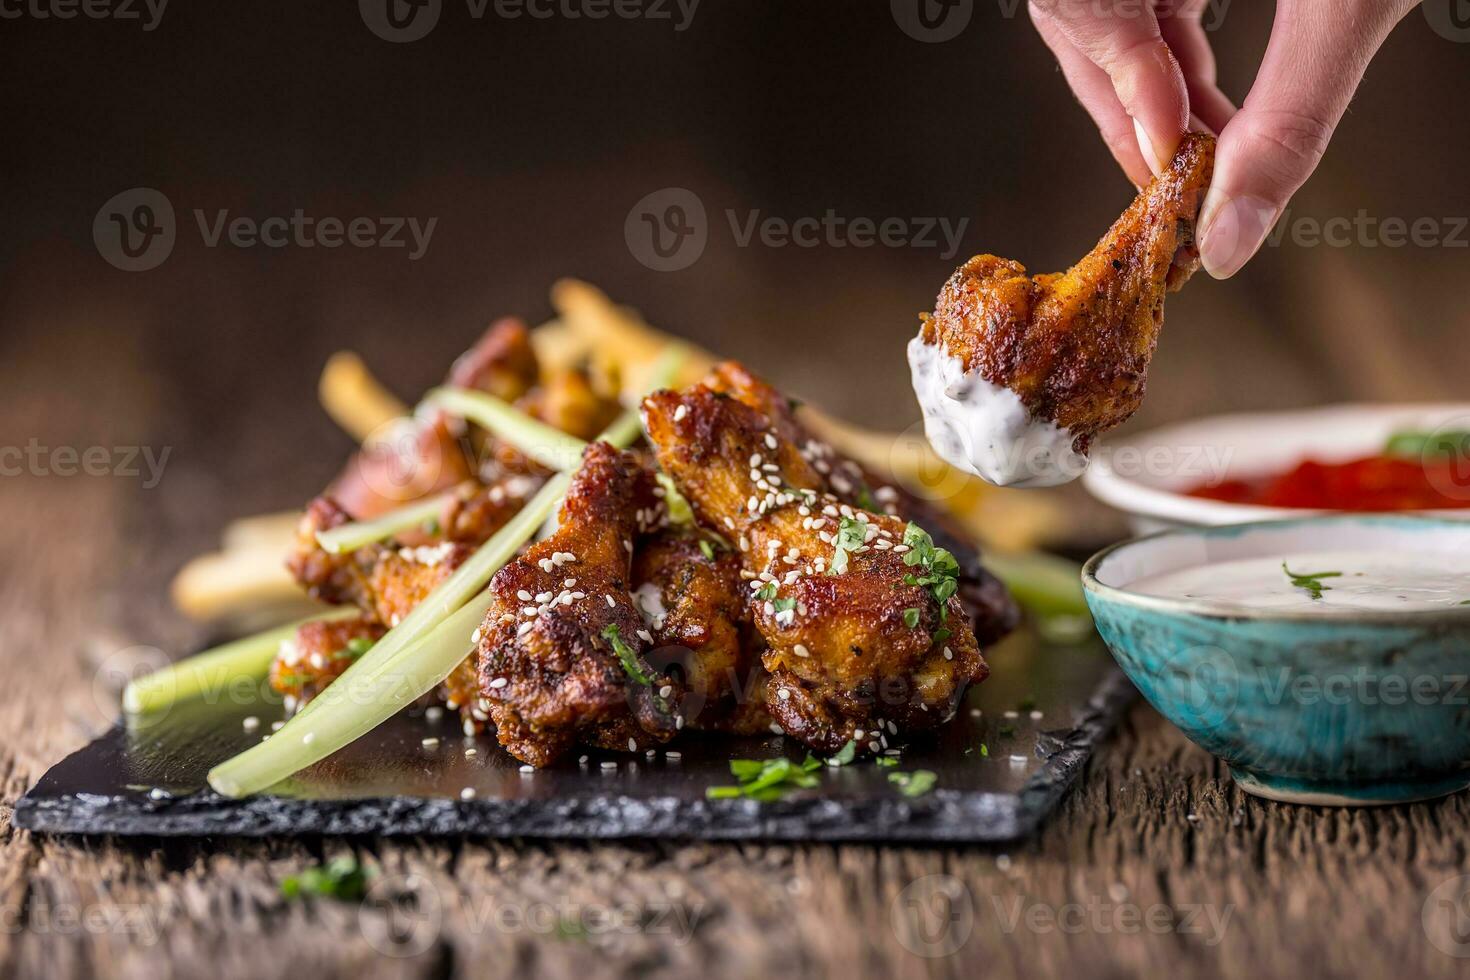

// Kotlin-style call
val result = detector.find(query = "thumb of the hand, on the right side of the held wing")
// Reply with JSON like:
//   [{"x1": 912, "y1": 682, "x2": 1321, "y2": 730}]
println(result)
[{"x1": 1200, "y1": 0, "x2": 1414, "y2": 279}]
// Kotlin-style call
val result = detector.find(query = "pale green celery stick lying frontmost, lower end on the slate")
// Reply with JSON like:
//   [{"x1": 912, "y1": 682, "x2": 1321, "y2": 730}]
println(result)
[{"x1": 209, "y1": 589, "x2": 495, "y2": 798}]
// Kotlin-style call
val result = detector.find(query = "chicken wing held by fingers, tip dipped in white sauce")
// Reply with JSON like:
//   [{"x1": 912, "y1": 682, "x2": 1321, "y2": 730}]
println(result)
[{"x1": 908, "y1": 134, "x2": 1214, "y2": 486}]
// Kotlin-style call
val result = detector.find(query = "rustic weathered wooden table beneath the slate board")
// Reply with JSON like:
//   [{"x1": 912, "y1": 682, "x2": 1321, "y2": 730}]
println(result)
[{"x1": 0, "y1": 301, "x2": 1470, "y2": 979}]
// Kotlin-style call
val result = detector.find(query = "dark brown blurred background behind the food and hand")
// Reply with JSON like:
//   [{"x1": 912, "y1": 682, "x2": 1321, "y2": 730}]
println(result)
[{"x1": 0, "y1": 0, "x2": 1470, "y2": 575}]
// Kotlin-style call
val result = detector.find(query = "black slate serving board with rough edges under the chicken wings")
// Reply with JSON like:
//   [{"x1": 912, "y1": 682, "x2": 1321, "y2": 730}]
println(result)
[{"x1": 15, "y1": 632, "x2": 1133, "y2": 842}]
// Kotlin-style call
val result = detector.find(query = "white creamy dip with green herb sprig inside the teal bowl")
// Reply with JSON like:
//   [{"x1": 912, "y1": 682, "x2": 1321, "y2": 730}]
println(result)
[{"x1": 1126, "y1": 551, "x2": 1470, "y2": 616}]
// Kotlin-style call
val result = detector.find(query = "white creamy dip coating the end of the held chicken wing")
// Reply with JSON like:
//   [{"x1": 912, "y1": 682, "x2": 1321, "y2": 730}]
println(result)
[{"x1": 908, "y1": 336, "x2": 1088, "y2": 486}]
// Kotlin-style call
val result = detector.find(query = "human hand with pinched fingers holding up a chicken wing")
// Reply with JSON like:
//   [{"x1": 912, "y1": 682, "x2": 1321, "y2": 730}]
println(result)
[{"x1": 1030, "y1": 0, "x2": 1417, "y2": 279}]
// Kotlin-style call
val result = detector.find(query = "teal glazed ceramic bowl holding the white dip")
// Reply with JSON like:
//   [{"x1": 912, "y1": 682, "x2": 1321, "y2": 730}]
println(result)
[{"x1": 1082, "y1": 516, "x2": 1470, "y2": 805}]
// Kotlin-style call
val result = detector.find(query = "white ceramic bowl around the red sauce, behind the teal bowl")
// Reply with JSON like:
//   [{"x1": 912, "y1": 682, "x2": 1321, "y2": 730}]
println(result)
[{"x1": 1082, "y1": 403, "x2": 1470, "y2": 533}]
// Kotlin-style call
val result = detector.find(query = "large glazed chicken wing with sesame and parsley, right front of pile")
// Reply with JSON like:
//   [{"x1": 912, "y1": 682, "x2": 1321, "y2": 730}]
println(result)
[{"x1": 644, "y1": 385, "x2": 986, "y2": 752}]
